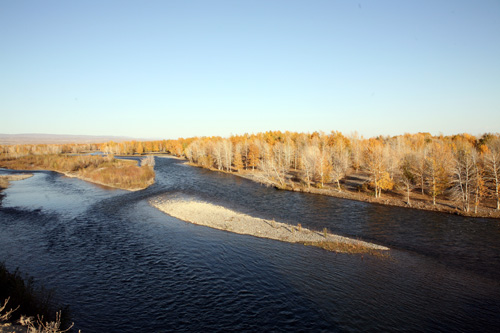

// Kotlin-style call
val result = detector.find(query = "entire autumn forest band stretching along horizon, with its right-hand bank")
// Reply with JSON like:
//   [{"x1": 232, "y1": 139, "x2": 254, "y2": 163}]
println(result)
[{"x1": 0, "y1": 131, "x2": 500, "y2": 217}]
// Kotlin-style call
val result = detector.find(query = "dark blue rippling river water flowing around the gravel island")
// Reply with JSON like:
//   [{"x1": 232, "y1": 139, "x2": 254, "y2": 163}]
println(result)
[{"x1": 0, "y1": 158, "x2": 500, "y2": 332}]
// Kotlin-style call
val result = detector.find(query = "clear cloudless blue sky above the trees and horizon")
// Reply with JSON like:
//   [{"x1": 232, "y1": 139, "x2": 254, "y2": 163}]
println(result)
[{"x1": 0, "y1": 0, "x2": 500, "y2": 138}]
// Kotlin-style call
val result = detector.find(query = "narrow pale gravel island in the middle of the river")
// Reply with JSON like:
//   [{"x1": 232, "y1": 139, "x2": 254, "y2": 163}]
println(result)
[{"x1": 150, "y1": 197, "x2": 389, "y2": 255}]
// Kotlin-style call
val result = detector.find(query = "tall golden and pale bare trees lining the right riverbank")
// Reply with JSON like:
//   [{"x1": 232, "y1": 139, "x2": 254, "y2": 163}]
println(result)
[{"x1": 183, "y1": 132, "x2": 500, "y2": 212}]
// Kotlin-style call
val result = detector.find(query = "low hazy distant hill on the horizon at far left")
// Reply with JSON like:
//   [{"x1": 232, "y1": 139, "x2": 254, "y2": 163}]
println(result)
[{"x1": 0, "y1": 133, "x2": 139, "y2": 145}]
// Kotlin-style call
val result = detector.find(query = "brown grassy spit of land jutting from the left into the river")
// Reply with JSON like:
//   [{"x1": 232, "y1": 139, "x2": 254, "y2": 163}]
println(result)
[{"x1": 0, "y1": 155, "x2": 155, "y2": 190}]
